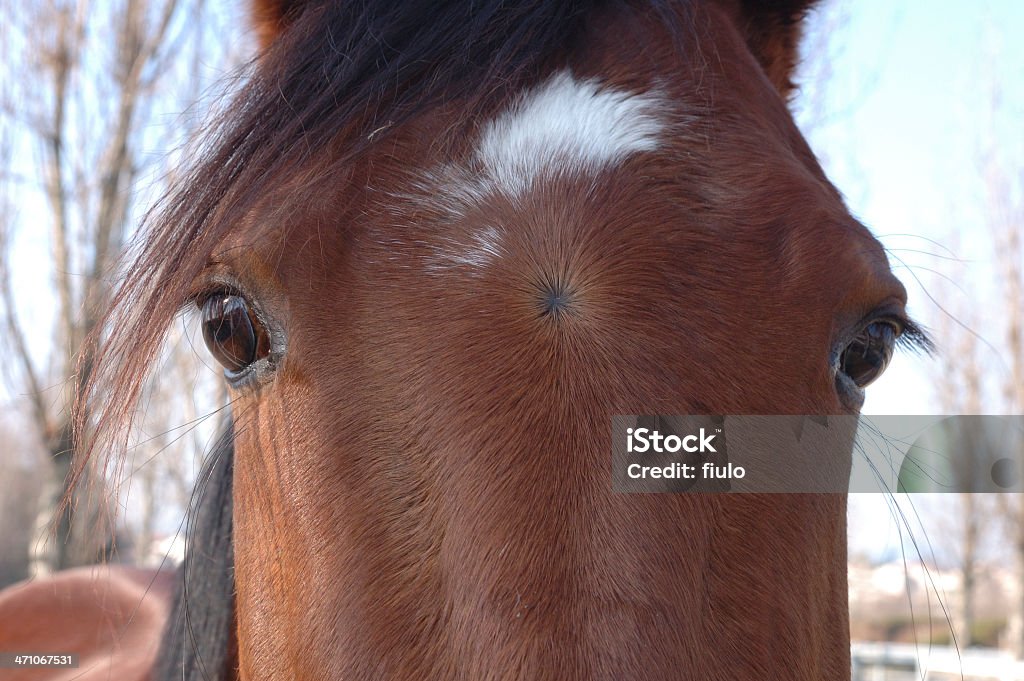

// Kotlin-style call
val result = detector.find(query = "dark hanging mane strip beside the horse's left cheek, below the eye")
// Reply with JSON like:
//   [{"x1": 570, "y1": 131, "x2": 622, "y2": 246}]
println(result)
[{"x1": 153, "y1": 428, "x2": 234, "y2": 681}]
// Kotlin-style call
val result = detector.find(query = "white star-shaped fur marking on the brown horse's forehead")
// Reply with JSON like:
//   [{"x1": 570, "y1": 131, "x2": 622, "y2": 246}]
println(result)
[{"x1": 387, "y1": 69, "x2": 682, "y2": 272}]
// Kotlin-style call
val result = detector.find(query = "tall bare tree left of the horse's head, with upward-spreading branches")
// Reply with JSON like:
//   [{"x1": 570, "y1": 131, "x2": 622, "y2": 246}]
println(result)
[{"x1": 0, "y1": 0, "x2": 238, "y2": 573}]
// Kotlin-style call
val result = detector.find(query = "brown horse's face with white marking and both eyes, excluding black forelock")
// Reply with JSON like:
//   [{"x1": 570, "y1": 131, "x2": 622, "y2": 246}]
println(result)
[{"x1": 184, "y1": 5, "x2": 905, "y2": 679}]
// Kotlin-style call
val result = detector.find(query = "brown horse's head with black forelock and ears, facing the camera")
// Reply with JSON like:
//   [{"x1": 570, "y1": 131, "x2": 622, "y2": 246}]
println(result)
[{"x1": 0, "y1": 0, "x2": 928, "y2": 680}]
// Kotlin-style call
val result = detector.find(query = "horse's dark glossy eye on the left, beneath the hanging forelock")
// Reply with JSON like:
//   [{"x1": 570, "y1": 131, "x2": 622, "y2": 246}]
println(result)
[{"x1": 201, "y1": 293, "x2": 270, "y2": 378}]
